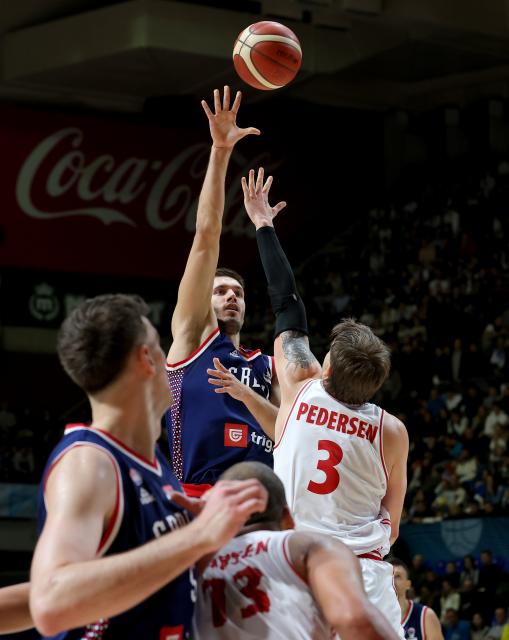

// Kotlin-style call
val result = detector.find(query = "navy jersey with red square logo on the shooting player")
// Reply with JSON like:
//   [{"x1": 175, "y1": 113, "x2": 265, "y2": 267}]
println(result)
[{"x1": 166, "y1": 329, "x2": 273, "y2": 484}]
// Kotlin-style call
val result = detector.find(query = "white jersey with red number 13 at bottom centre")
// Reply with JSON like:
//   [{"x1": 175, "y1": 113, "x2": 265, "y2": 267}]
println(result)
[{"x1": 193, "y1": 531, "x2": 333, "y2": 640}]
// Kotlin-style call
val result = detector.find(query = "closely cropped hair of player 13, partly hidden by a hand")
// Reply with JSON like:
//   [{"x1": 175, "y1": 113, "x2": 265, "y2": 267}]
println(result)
[{"x1": 220, "y1": 461, "x2": 287, "y2": 525}]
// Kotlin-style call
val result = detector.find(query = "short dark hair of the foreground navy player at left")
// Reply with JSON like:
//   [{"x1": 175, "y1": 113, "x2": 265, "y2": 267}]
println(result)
[{"x1": 57, "y1": 294, "x2": 149, "y2": 393}]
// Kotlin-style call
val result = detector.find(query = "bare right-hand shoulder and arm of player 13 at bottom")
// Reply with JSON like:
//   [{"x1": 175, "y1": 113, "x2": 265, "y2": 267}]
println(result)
[{"x1": 288, "y1": 532, "x2": 399, "y2": 640}]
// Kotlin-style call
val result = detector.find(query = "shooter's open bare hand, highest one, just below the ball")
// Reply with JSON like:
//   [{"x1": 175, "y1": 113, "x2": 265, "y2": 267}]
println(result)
[{"x1": 201, "y1": 85, "x2": 260, "y2": 149}]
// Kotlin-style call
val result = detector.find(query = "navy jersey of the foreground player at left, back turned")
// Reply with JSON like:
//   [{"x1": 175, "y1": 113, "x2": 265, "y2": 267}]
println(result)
[{"x1": 38, "y1": 425, "x2": 196, "y2": 640}]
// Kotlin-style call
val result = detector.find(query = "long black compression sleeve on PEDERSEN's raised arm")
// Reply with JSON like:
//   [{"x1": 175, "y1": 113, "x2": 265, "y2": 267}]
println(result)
[{"x1": 256, "y1": 227, "x2": 308, "y2": 337}]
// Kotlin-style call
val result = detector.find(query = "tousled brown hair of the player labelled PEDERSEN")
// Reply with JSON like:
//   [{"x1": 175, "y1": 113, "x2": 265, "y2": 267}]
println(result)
[{"x1": 325, "y1": 318, "x2": 391, "y2": 404}]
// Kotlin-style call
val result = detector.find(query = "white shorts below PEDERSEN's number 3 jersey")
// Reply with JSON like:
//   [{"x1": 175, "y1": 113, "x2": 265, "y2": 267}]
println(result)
[{"x1": 359, "y1": 558, "x2": 405, "y2": 640}]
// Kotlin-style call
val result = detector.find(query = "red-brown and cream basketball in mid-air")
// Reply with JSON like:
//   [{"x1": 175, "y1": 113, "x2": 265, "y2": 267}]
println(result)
[{"x1": 233, "y1": 21, "x2": 302, "y2": 91}]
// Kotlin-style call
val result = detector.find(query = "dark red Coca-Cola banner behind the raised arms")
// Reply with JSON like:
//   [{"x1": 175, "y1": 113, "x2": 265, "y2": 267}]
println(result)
[{"x1": 0, "y1": 105, "x2": 276, "y2": 278}]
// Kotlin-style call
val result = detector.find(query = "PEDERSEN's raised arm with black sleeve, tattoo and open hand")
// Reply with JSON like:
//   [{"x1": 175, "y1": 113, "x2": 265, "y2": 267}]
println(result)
[{"x1": 242, "y1": 169, "x2": 321, "y2": 405}]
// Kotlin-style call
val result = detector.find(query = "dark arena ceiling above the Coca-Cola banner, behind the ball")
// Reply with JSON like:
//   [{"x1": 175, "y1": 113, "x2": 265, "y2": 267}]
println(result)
[{"x1": 0, "y1": 0, "x2": 509, "y2": 112}]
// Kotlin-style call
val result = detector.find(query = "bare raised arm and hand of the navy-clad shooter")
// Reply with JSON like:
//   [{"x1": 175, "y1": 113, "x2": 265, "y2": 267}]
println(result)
[{"x1": 168, "y1": 86, "x2": 260, "y2": 363}]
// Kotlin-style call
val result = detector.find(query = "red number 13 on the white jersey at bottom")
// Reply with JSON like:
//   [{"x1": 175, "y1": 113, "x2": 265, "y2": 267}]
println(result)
[{"x1": 202, "y1": 567, "x2": 270, "y2": 627}]
